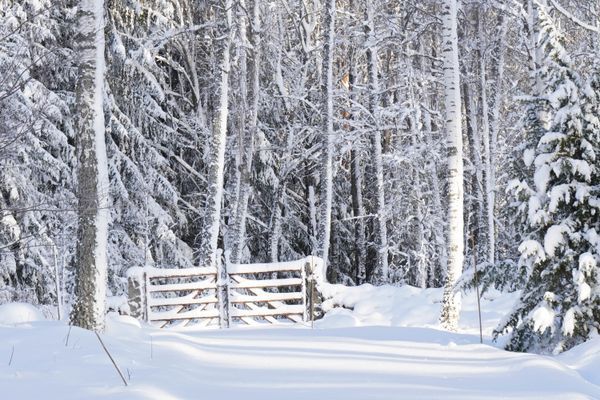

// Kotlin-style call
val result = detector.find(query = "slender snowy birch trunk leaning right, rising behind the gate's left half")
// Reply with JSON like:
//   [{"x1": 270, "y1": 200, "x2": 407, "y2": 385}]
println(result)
[{"x1": 200, "y1": 0, "x2": 232, "y2": 266}]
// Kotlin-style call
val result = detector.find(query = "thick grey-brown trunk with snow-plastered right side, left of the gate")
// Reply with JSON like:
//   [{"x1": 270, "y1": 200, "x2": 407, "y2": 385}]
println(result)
[{"x1": 71, "y1": 0, "x2": 110, "y2": 331}]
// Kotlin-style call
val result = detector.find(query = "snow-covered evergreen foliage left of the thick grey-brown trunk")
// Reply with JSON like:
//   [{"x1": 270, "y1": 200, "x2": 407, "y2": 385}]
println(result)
[{"x1": 0, "y1": 0, "x2": 75, "y2": 304}]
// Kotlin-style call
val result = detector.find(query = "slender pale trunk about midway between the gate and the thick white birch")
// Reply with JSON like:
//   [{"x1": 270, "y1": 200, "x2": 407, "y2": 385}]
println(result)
[{"x1": 365, "y1": 1, "x2": 389, "y2": 283}]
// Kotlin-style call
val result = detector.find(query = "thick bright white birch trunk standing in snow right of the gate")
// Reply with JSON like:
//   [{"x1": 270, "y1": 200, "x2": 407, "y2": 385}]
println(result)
[{"x1": 440, "y1": 0, "x2": 464, "y2": 330}]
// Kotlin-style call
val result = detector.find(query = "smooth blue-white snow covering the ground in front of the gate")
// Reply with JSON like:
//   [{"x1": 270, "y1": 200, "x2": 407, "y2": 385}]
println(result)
[{"x1": 0, "y1": 286, "x2": 600, "y2": 400}]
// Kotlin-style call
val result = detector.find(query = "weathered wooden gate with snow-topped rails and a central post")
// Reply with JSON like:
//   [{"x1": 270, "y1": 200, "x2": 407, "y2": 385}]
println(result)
[{"x1": 128, "y1": 256, "x2": 322, "y2": 328}]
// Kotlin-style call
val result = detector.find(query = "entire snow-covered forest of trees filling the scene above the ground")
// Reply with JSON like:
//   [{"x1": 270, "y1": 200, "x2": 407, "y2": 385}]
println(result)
[{"x1": 0, "y1": 0, "x2": 600, "y2": 351}]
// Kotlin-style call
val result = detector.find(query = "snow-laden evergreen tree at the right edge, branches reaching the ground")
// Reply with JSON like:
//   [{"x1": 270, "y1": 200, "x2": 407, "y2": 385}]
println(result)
[{"x1": 496, "y1": 6, "x2": 600, "y2": 352}]
